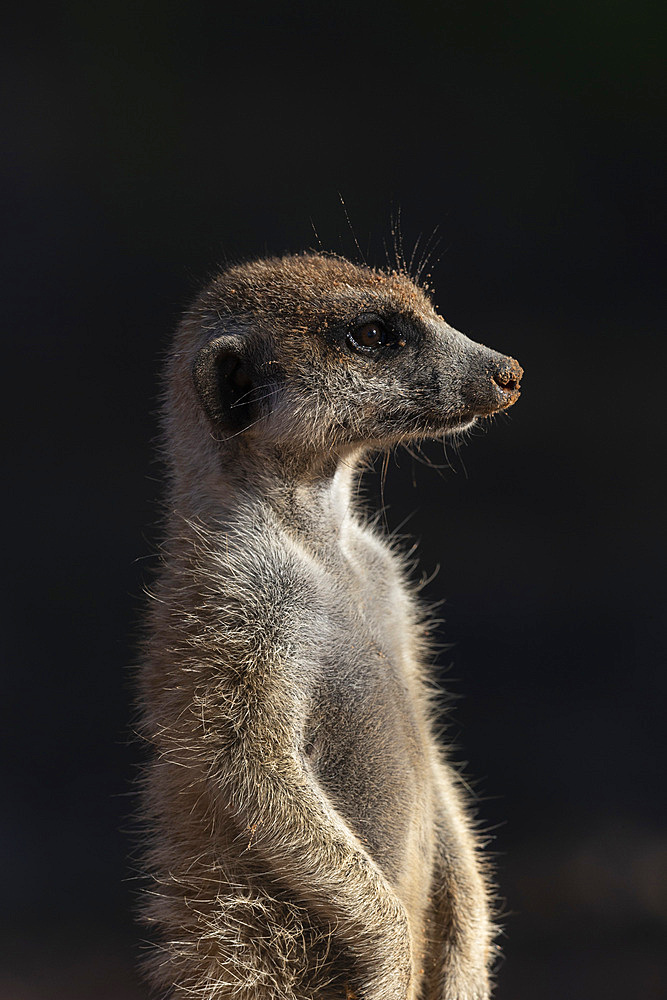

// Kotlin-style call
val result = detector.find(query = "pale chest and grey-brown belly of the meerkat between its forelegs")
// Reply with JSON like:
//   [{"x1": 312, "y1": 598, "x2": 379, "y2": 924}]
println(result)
[{"x1": 260, "y1": 521, "x2": 434, "y2": 925}]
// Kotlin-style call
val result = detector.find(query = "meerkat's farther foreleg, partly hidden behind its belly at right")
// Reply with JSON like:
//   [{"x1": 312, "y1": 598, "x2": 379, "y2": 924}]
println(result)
[{"x1": 423, "y1": 763, "x2": 495, "y2": 1000}]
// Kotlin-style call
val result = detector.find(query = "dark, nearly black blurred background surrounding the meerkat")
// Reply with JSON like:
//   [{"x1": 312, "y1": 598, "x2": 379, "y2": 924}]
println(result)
[{"x1": 0, "y1": 0, "x2": 667, "y2": 1000}]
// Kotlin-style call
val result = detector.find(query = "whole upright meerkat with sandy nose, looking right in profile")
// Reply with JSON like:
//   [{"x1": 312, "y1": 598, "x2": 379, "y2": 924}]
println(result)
[{"x1": 141, "y1": 254, "x2": 522, "y2": 1000}]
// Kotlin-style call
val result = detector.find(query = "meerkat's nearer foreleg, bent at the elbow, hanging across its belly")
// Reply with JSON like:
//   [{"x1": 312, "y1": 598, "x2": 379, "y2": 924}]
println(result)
[{"x1": 218, "y1": 705, "x2": 416, "y2": 1000}]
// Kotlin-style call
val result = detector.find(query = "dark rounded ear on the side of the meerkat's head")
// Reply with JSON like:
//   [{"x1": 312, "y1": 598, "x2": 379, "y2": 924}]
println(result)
[{"x1": 192, "y1": 334, "x2": 257, "y2": 431}]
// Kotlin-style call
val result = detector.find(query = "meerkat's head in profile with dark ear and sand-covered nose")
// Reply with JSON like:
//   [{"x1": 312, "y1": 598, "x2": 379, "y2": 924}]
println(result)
[{"x1": 189, "y1": 254, "x2": 523, "y2": 458}]
